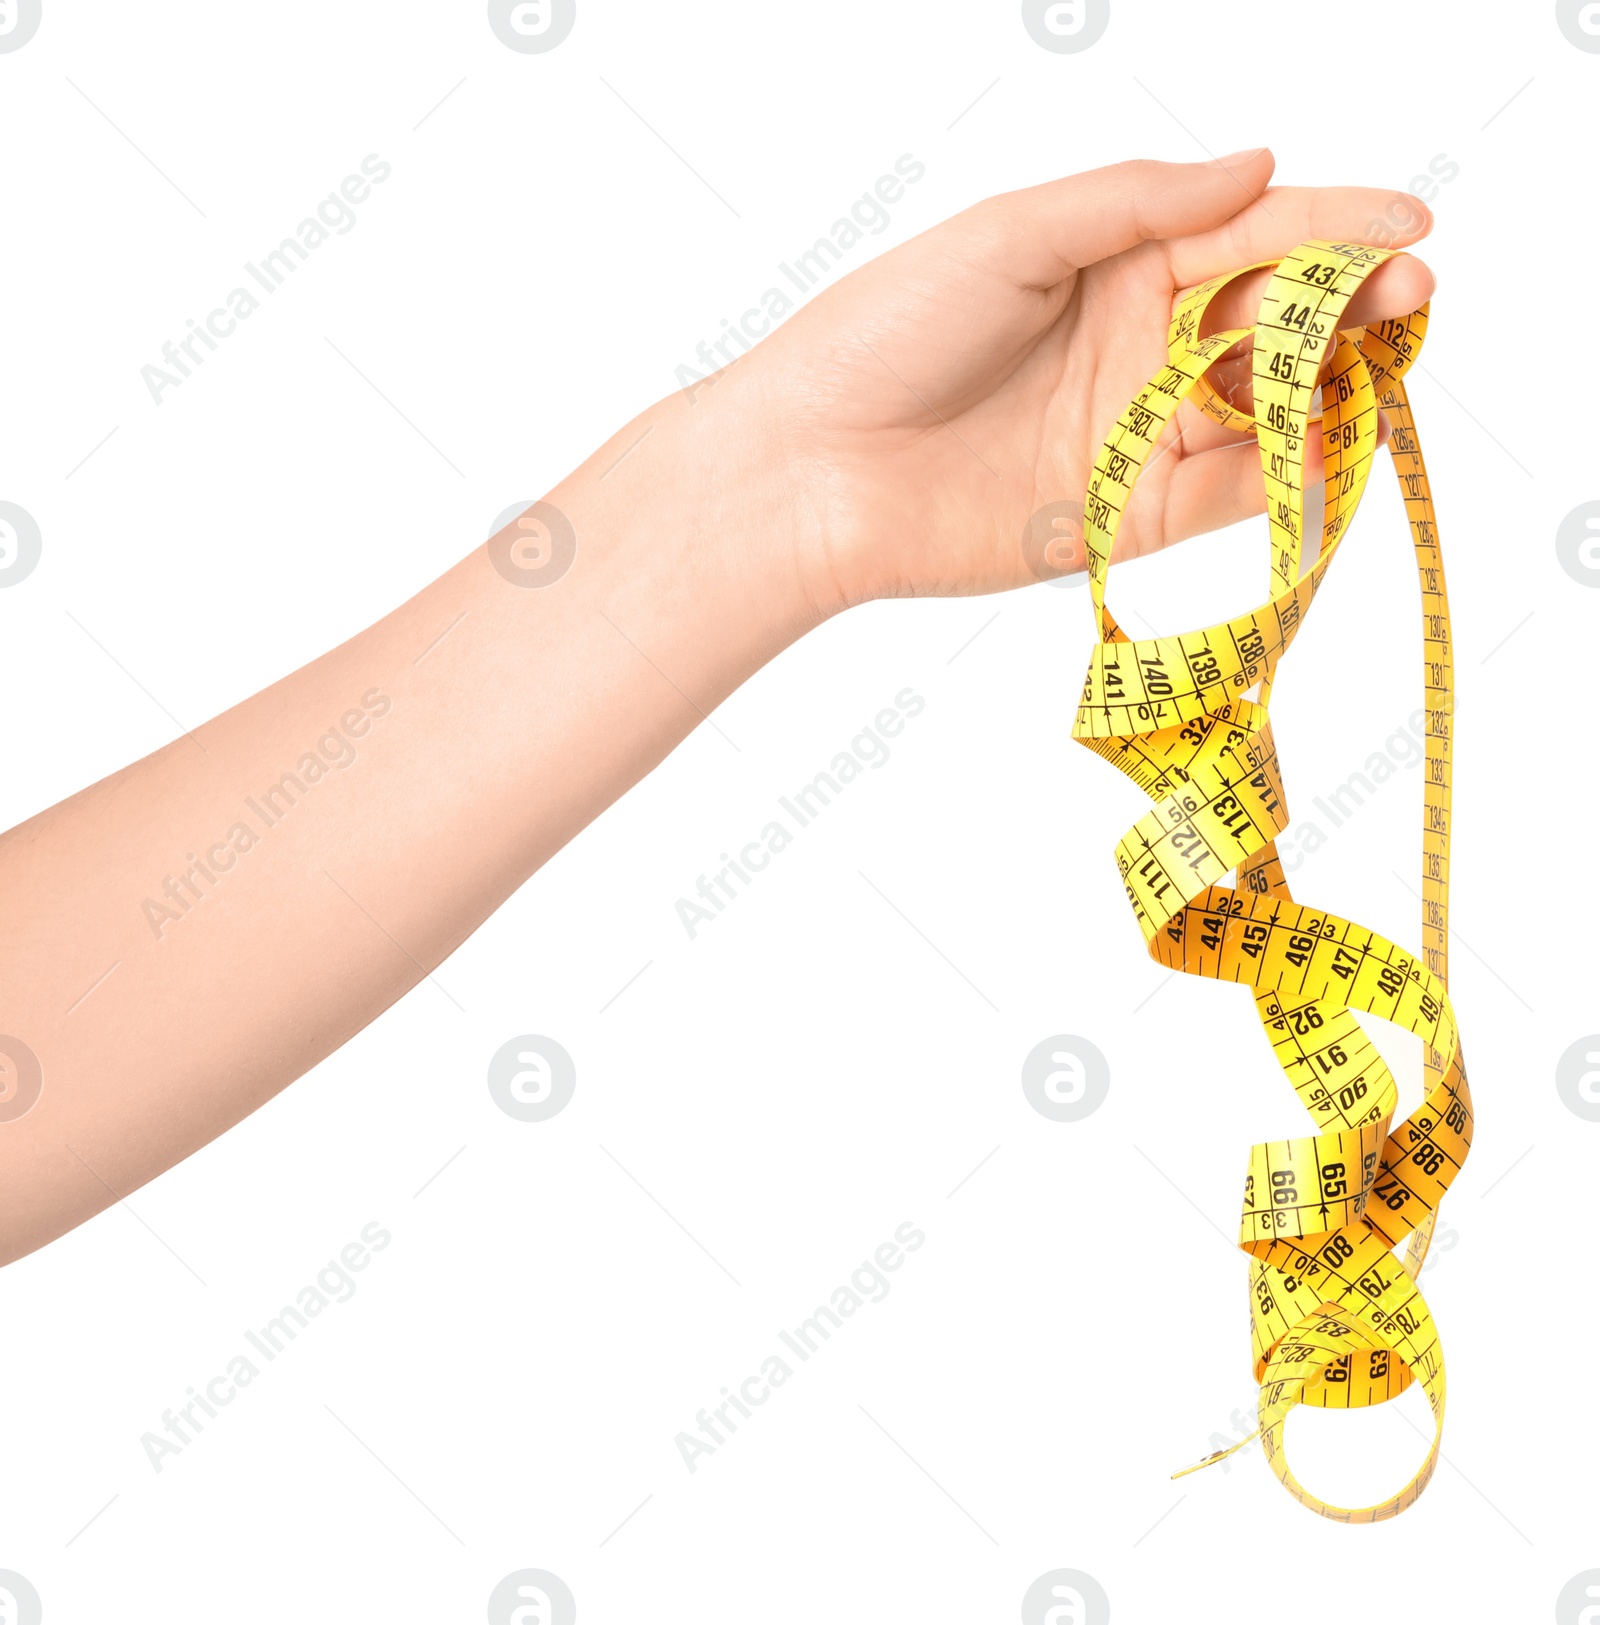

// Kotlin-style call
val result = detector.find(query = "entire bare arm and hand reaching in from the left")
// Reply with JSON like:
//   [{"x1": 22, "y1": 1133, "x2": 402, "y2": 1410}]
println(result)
[{"x1": 0, "y1": 150, "x2": 1433, "y2": 1263}]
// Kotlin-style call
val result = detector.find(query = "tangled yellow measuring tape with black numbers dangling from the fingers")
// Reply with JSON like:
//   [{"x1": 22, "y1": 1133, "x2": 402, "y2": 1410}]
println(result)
[{"x1": 1072, "y1": 242, "x2": 1472, "y2": 1523}]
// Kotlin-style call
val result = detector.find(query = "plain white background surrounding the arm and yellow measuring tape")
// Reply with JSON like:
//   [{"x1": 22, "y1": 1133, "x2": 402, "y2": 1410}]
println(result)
[{"x1": 0, "y1": 0, "x2": 1600, "y2": 1625}]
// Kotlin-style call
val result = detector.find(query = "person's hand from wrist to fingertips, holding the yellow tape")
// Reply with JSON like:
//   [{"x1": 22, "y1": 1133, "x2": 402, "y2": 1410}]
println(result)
[{"x1": 716, "y1": 148, "x2": 1433, "y2": 614}]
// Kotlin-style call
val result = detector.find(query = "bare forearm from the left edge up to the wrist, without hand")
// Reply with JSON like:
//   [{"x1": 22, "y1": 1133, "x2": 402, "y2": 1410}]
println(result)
[{"x1": 0, "y1": 383, "x2": 817, "y2": 1263}]
